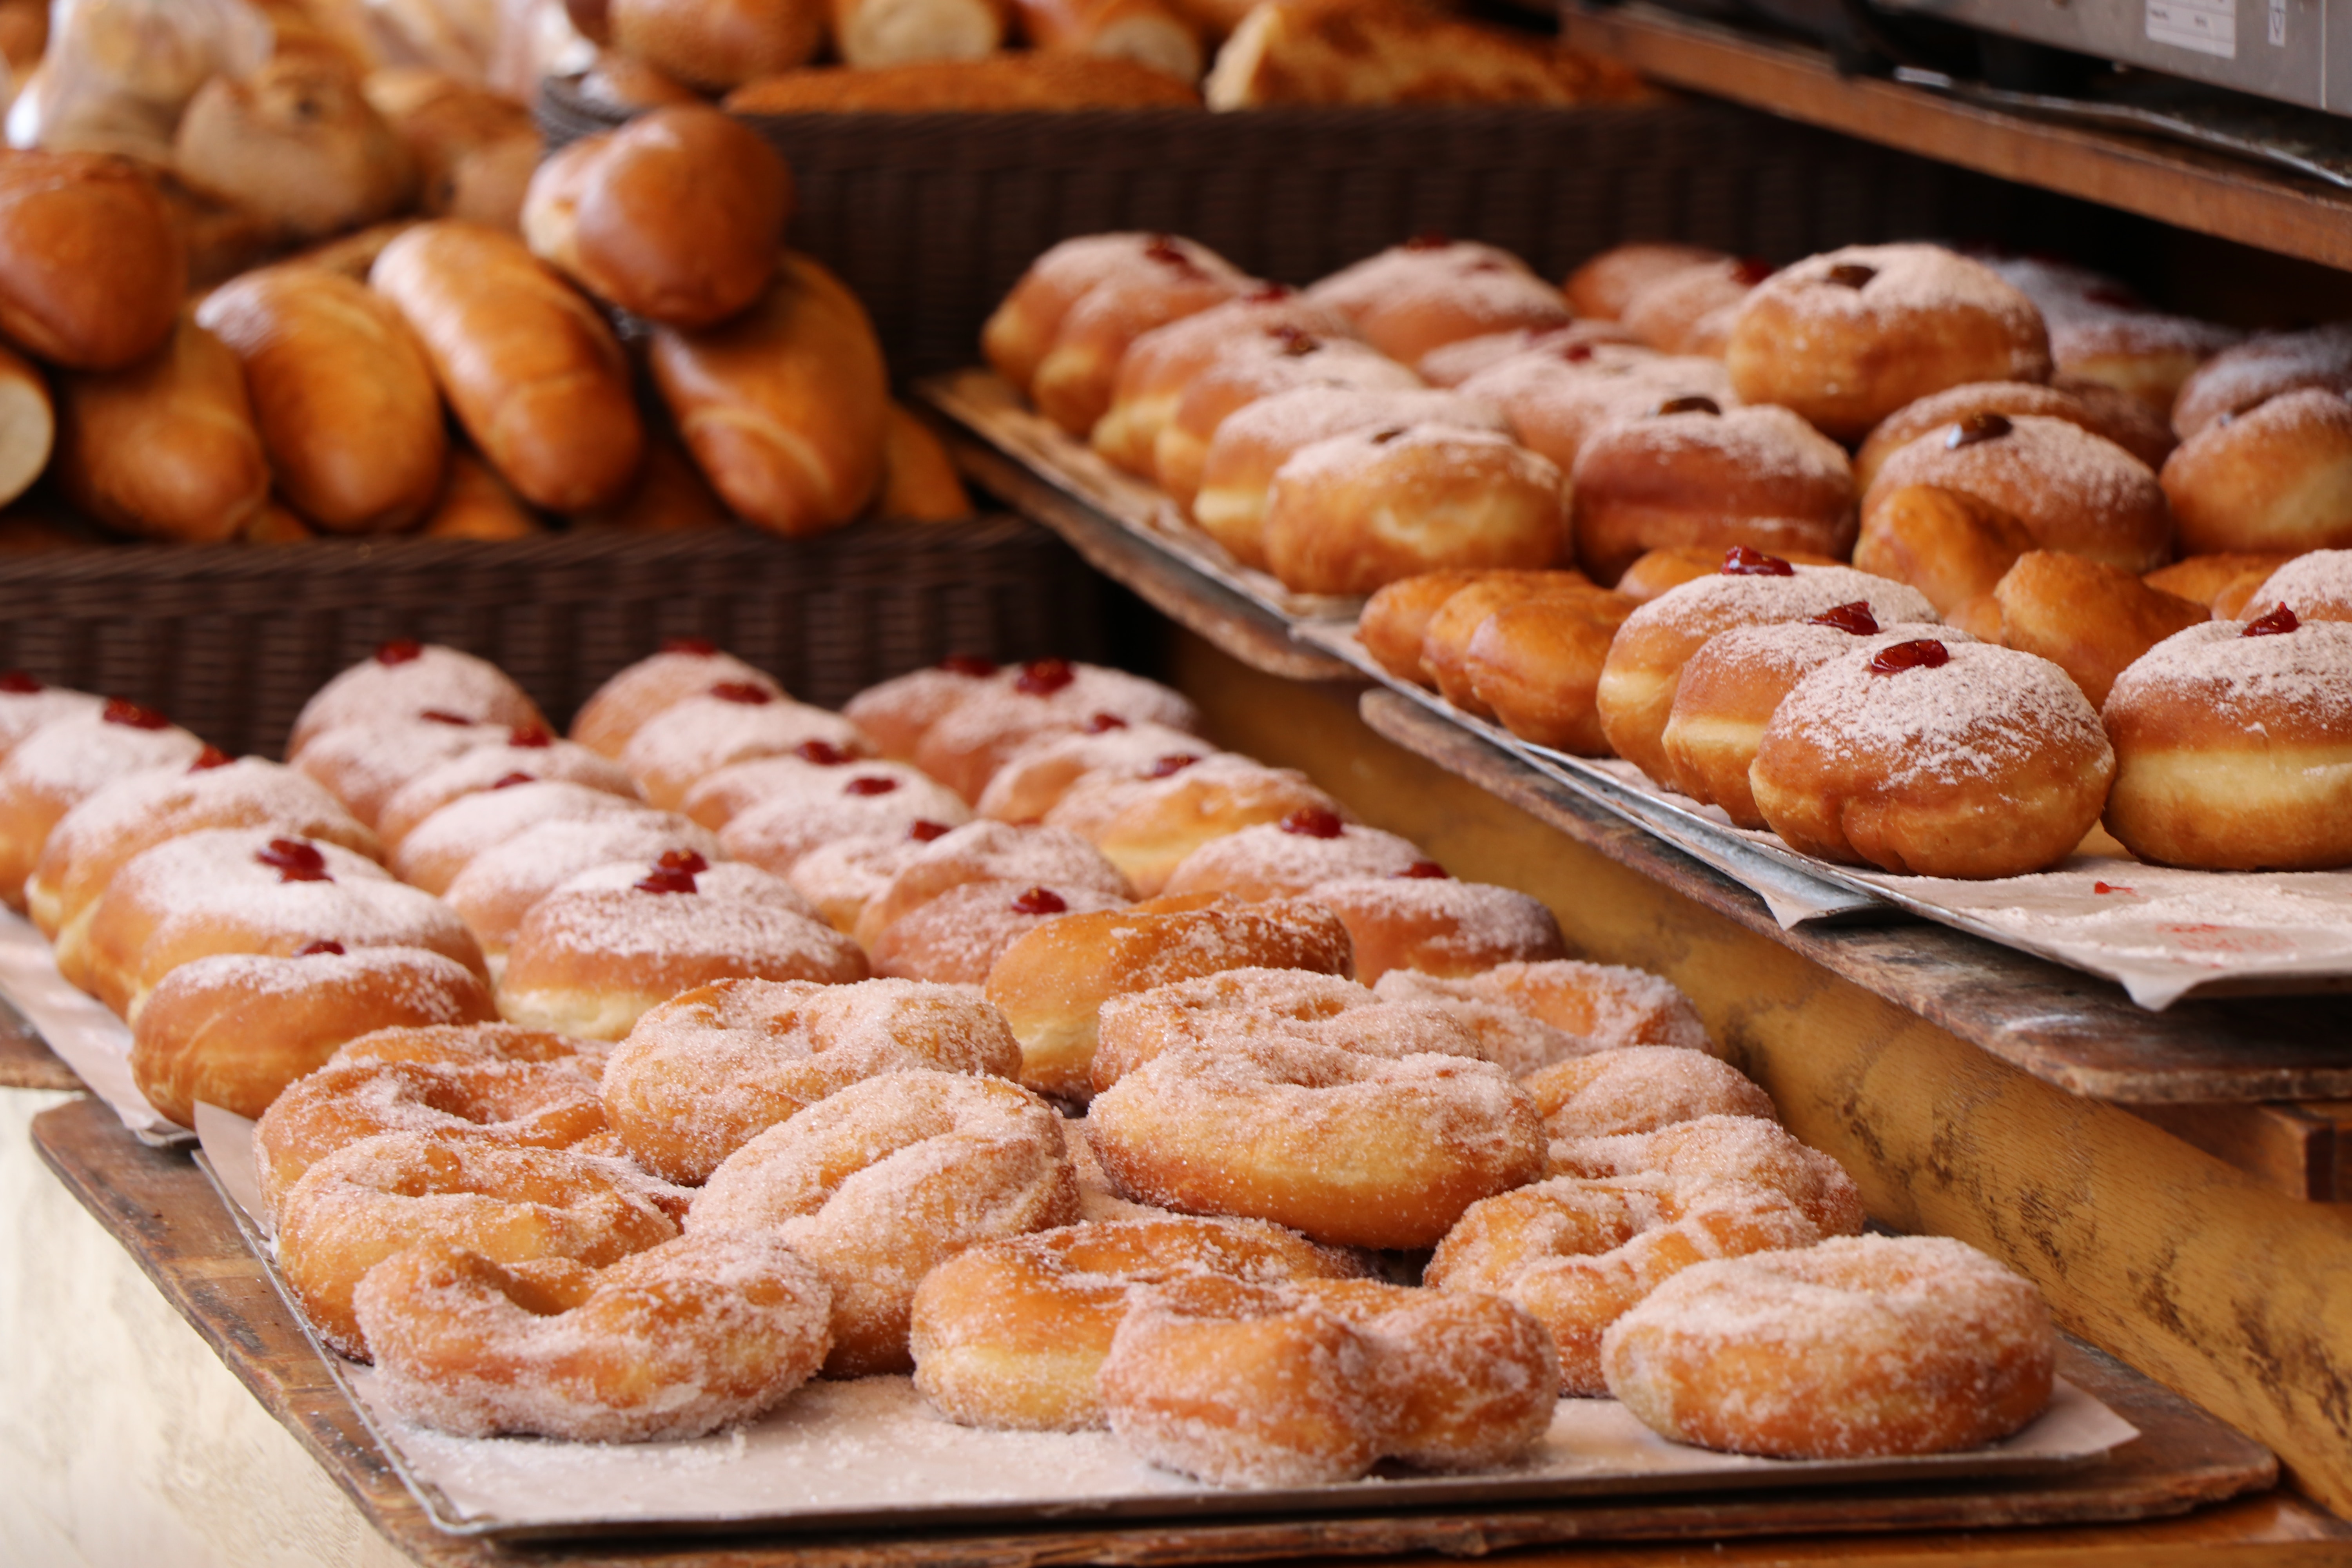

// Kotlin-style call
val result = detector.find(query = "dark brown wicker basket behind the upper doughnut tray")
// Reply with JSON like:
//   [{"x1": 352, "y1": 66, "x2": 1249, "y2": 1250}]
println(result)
[{"x1": 539, "y1": 80, "x2": 2112, "y2": 379}]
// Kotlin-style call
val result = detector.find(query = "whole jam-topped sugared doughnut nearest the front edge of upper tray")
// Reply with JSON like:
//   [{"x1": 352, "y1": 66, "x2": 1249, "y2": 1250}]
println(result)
[{"x1": 1748, "y1": 639, "x2": 2114, "y2": 877}]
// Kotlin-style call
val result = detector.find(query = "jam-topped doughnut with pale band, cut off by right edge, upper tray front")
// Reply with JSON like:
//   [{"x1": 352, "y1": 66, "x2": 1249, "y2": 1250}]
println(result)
[{"x1": 2103, "y1": 611, "x2": 2352, "y2": 872}]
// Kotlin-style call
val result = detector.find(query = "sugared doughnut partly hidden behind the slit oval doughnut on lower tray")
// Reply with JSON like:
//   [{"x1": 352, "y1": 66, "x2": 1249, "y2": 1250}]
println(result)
[{"x1": 604, "y1": 980, "x2": 1021, "y2": 1187}]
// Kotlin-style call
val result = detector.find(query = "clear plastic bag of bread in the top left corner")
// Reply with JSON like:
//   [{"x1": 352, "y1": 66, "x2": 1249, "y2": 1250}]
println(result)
[{"x1": 7, "y1": 0, "x2": 270, "y2": 165}]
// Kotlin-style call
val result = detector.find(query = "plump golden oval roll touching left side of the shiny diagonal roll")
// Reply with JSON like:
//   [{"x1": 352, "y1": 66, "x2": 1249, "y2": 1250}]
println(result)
[{"x1": 195, "y1": 266, "x2": 449, "y2": 534}]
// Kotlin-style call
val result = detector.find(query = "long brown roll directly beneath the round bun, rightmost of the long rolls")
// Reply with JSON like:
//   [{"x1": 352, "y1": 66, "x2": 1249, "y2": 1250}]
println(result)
[{"x1": 652, "y1": 254, "x2": 889, "y2": 536}]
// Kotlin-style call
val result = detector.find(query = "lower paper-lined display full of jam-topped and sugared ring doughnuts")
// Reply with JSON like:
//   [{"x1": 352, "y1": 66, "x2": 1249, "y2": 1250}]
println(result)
[{"x1": 0, "y1": 642, "x2": 2131, "y2": 1528}]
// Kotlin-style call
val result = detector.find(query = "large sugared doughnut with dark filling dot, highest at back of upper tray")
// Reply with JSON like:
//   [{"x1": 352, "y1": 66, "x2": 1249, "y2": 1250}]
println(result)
[{"x1": 1724, "y1": 245, "x2": 2051, "y2": 442}]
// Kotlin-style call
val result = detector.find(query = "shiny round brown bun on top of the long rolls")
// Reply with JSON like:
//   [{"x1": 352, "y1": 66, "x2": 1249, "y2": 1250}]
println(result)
[{"x1": 522, "y1": 103, "x2": 793, "y2": 327}]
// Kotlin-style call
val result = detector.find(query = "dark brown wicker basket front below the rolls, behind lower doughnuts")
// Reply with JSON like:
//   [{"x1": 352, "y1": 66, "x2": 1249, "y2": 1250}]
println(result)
[{"x1": 0, "y1": 517, "x2": 1103, "y2": 757}]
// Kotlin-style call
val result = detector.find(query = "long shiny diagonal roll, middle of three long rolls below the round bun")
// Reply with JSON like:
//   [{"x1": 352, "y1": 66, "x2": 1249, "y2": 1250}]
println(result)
[{"x1": 369, "y1": 219, "x2": 644, "y2": 510}]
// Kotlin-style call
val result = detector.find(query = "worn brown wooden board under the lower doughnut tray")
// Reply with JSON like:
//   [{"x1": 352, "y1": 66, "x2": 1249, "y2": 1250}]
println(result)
[{"x1": 33, "y1": 1100, "x2": 2277, "y2": 1568}]
